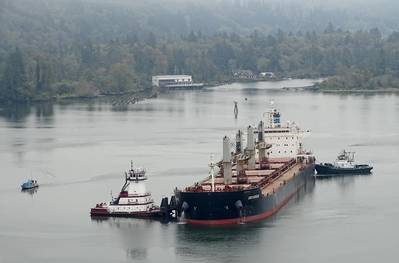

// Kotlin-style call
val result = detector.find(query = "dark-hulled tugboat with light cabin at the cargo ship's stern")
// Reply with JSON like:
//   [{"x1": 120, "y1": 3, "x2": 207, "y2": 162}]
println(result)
[{"x1": 315, "y1": 150, "x2": 373, "y2": 175}]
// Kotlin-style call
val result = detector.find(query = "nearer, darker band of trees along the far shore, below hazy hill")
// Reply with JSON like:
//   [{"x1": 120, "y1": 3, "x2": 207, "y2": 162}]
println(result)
[{"x1": 0, "y1": 27, "x2": 399, "y2": 101}]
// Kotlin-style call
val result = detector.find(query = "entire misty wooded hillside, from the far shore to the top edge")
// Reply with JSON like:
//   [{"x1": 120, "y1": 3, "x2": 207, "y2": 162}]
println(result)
[{"x1": 0, "y1": 0, "x2": 399, "y2": 101}]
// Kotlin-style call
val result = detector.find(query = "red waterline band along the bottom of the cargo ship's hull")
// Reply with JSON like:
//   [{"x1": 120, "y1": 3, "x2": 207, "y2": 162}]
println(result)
[{"x1": 186, "y1": 184, "x2": 300, "y2": 226}]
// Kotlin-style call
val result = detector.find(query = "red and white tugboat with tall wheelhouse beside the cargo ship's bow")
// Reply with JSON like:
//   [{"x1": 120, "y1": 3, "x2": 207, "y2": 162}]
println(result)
[{"x1": 90, "y1": 162, "x2": 162, "y2": 218}]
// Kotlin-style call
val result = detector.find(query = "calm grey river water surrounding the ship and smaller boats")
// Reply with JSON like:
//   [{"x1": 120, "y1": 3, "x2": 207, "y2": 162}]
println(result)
[{"x1": 0, "y1": 80, "x2": 399, "y2": 263}]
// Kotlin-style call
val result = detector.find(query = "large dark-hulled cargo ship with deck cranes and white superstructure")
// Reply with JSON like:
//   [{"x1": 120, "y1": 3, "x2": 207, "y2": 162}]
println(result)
[{"x1": 175, "y1": 106, "x2": 315, "y2": 225}]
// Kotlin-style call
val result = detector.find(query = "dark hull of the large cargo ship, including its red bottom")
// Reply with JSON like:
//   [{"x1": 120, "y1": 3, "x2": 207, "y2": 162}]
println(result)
[{"x1": 177, "y1": 164, "x2": 314, "y2": 225}]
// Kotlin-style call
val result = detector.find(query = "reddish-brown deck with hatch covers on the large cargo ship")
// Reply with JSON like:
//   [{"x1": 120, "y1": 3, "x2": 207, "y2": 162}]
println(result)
[{"x1": 185, "y1": 158, "x2": 301, "y2": 195}]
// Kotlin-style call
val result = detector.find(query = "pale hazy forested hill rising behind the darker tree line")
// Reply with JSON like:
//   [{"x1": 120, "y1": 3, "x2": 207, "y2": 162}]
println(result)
[{"x1": 0, "y1": 0, "x2": 399, "y2": 52}]
